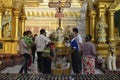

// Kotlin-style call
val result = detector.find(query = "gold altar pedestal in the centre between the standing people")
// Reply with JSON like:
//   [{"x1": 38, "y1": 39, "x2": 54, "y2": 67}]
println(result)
[{"x1": 51, "y1": 42, "x2": 71, "y2": 74}]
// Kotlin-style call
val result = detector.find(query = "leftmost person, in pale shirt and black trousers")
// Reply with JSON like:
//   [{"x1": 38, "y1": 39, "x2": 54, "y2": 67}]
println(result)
[{"x1": 19, "y1": 31, "x2": 32, "y2": 74}]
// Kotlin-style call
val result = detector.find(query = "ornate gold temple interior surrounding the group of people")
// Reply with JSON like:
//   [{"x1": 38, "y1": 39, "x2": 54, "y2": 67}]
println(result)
[{"x1": 0, "y1": 0, "x2": 120, "y2": 80}]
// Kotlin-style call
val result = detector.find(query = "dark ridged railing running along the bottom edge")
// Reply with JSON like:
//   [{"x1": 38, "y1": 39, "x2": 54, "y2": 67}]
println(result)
[{"x1": 0, "y1": 73, "x2": 120, "y2": 80}]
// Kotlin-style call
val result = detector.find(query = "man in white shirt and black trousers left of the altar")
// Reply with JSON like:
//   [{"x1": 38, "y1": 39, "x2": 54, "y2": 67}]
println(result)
[{"x1": 35, "y1": 29, "x2": 50, "y2": 72}]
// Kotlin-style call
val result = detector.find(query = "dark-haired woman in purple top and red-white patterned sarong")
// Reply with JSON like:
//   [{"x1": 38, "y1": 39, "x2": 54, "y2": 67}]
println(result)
[{"x1": 82, "y1": 35, "x2": 96, "y2": 74}]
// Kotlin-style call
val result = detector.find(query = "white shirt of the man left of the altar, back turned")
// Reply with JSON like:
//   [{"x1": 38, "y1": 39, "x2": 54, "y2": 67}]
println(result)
[{"x1": 35, "y1": 34, "x2": 50, "y2": 51}]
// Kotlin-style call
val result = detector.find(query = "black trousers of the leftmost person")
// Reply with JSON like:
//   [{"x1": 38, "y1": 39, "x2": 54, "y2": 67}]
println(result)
[{"x1": 19, "y1": 53, "x2": 30, "y2": 73}]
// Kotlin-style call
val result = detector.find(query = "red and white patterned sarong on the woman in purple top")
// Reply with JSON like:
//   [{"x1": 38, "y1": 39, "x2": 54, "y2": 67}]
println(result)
[{"x1": 82, "y1": 56, "x2": 95, "y2": 74}]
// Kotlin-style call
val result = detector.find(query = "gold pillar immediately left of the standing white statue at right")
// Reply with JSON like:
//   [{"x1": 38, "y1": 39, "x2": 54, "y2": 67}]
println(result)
[{"x1": 90, "y1": 11, "x2": 96, "y2": 41}]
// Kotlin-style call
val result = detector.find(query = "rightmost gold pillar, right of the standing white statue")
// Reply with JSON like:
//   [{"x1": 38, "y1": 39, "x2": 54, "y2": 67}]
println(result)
[{"x1": 108, "y1": 9, "x2": 115, "y2": 42}]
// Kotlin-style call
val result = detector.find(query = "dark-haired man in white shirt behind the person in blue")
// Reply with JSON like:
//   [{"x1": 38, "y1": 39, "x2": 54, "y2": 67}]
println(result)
[{"x1": 72, "y1": 28, "x2": 82, "y2": 72}]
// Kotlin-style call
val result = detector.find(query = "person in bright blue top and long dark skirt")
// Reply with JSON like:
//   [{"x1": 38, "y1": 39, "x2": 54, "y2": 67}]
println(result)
[{"x1": 69, "y1": 34, "x2": 81, "y2": 74}]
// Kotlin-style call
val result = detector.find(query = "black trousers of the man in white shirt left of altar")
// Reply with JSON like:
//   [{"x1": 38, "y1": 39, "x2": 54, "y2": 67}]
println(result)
[{"x1": 37, "y1": 51, "x2": 43, "y2": 72}]
